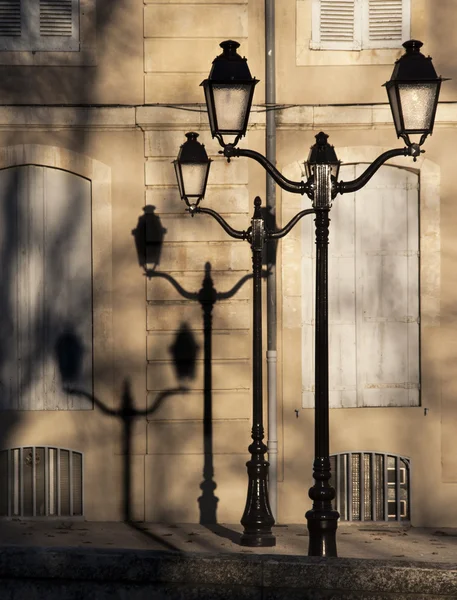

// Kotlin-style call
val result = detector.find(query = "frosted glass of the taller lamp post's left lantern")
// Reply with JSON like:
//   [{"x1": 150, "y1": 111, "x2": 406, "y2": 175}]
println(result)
[{"x1": 212, "y1": 83, "x2": 252, "y2": 133}]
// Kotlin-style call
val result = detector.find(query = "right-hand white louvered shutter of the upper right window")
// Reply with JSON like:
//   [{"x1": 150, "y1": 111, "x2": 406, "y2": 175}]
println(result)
[{"x1": 362, "y1": 0, "x2": 410, "y2": 48}]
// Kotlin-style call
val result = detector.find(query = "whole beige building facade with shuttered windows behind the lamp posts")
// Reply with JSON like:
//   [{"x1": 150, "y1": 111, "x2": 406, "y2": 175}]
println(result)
[{"x1": 0, "y1": 0, "x2": 457, "y2": 526}]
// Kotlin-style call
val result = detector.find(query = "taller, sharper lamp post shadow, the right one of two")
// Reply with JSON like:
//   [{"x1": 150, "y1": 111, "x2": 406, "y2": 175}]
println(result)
[{"x1": 132, "y1": 205, "x2": 252, "y2": 543}]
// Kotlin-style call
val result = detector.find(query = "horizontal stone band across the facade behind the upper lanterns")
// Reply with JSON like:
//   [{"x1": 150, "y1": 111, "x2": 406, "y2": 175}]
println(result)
[{"x1": 0, "y1": 102, "x2": 457, "y2": 131}]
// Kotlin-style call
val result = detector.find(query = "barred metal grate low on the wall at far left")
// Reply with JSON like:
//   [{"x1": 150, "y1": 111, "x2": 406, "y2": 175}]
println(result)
[{"x1": 0, "y1": 446, "x2": 83, "y2": 517}]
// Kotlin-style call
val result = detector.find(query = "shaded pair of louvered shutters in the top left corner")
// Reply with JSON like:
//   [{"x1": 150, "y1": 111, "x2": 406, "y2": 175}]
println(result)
[{"x1": 0, "y1": 0, "x2": 79, "y2": 52}]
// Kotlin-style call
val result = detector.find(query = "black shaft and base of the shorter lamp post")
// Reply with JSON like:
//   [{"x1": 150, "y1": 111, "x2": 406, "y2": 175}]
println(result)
[{"x1": 241, "y1": 198, "x2": 276, "y2": 547}]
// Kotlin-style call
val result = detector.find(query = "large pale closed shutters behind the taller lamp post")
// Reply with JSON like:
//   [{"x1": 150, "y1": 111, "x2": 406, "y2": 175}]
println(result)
[{"x1": 302, "y1": 165, "x2": 419, "y2": 408}]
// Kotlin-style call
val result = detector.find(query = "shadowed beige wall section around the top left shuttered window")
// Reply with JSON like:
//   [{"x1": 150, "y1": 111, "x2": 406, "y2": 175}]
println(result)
[{"x1": 0, "y1": 0, "x2": 144, "y2": 105}]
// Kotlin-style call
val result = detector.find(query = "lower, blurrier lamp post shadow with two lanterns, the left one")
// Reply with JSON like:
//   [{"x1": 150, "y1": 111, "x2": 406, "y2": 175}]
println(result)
[{"x1": 55, "y1": 324, "x2": 198, "y2": 550}]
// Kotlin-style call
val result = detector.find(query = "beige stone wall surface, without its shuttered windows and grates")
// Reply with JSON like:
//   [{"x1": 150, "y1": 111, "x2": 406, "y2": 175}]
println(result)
[{"x1": 0, "y1": 0, "x2": 457, "y2": 526}]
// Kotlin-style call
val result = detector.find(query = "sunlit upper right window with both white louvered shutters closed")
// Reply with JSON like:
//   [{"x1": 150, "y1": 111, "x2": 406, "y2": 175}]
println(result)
[{"x1": 310, "y1": 0, "x2": 411, "y2": 50}]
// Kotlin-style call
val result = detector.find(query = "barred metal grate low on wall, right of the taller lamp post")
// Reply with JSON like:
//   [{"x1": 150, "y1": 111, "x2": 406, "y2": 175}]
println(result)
[{"x1": 330, "y1": 452, "x2": 410, "y2": 521}]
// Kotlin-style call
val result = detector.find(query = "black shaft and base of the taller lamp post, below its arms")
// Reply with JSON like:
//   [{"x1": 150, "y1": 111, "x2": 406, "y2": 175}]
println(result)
[{"x1": 306, "y1": 207, "x2": 339, "y2": 556}]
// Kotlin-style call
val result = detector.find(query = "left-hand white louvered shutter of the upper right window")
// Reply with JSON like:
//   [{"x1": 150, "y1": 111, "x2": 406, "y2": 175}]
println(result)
[{"x1": 311, "y1": 0, "x2": 361, "y2": 50}]
